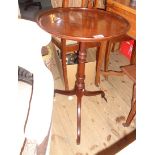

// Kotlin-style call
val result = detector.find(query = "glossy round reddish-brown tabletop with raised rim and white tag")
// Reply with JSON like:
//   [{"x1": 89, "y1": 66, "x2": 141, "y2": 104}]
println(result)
[{"x1": 37, "y1": 8, "x2": 130, "y2": 42}]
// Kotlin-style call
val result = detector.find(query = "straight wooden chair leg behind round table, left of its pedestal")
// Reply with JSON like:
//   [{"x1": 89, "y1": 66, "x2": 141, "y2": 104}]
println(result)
[{"x1": 61, "y1": 39, "x2": 69, "y2": 90}]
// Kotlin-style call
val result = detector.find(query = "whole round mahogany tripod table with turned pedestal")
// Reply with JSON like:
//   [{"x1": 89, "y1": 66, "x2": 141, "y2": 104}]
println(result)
[{"x1": 36, "y1": 7, "x2": 130, "y2": 144}]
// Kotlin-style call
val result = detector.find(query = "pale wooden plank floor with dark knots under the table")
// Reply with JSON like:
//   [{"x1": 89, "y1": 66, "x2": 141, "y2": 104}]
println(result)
[{"x1": 46, "y1": 45, "x2": 136, "y2": 155}]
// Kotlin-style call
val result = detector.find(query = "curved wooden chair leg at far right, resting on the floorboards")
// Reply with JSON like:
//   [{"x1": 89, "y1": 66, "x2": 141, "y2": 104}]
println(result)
[{"x1": 123, "y1": 84, "x2": 136, "y2": 127}]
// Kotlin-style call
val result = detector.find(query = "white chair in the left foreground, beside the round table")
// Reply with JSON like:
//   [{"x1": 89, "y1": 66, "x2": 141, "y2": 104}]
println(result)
[{"x1": 17, "y1": 19, "x2": 54, "y2": 155}]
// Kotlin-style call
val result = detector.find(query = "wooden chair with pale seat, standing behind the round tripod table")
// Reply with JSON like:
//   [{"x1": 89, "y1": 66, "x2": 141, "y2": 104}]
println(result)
[{"x1": 52, "y1": 0, "x2": 100, "y2": 90}]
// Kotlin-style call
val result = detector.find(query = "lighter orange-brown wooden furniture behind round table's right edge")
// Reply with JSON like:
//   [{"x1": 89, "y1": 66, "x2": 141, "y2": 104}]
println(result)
[{"x1": 106, "y1": 0, "x2": 136, "y2": 39}]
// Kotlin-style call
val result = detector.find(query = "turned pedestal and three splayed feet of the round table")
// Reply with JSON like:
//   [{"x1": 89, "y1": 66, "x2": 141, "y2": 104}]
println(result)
[{"x1": 55, "y1": 42, "x2": 107, "y2": 144}]
